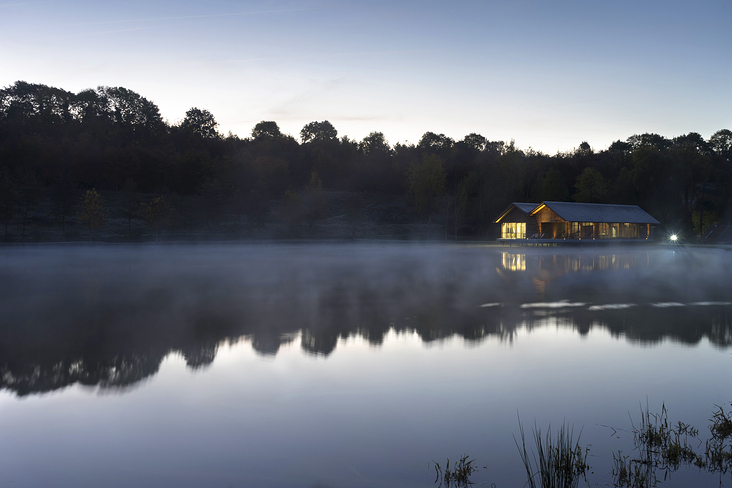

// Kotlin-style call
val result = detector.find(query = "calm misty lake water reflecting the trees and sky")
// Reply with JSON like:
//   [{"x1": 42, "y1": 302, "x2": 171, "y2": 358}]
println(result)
[{"x1": 0, "y1": 244, "x2": 732, "y2": 488}]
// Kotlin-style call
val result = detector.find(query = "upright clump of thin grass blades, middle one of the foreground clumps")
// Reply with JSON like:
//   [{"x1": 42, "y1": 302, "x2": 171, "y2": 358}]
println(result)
[{"x1": 514, "y1": 419, "x2": 589, "y2": 488}]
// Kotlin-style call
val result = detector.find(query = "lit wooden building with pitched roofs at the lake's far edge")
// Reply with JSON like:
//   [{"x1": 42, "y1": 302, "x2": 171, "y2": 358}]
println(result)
[{"x1": 495, "y1": 202, "x2": 659, "y2": 241}]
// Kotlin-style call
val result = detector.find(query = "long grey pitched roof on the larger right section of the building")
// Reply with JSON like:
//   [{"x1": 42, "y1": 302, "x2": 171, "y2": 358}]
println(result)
[{"x1": 531, "y1": 202, "x2": 659, "y2": 224}]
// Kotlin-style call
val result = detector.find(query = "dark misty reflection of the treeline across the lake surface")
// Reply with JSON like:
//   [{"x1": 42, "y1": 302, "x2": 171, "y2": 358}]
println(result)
[{"x1": 0, "y1": 248, "x2": 732, "y2": 395}]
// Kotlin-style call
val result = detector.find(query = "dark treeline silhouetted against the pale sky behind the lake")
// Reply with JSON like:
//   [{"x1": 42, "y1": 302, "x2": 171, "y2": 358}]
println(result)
[{"x1": 0, "y1": 81, "x2": 732, "y2": 238}]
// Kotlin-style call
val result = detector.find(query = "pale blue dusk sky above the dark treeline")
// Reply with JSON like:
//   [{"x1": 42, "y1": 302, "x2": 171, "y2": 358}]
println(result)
[{"x1": 0, "y1": 0, "x2": 732, "y2": 154}]
